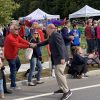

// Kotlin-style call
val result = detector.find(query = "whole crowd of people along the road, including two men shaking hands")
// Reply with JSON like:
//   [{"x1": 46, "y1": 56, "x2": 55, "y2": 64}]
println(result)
[{"x1": 0, "y1": 19, "x2": 100, "y2": 100}]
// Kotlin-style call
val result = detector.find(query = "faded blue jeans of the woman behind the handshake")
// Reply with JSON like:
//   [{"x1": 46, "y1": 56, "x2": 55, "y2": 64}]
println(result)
[{"x1": 28, "y1": 57, "x2": 42, "y2": 82}]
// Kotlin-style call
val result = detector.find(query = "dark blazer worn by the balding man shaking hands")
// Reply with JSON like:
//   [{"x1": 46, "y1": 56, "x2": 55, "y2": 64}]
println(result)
[{"x1": 37, "y1": 32, "x2": 68, "y2": 65}]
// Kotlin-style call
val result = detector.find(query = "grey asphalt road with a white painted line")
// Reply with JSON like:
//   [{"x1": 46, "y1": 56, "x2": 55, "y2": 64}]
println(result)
[{"x1": 4, "y1": 76, "x2": 100, "y2": 100}]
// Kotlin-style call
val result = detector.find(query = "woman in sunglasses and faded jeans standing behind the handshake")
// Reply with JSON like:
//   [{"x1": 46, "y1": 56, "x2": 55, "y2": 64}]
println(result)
[{"x1": 28, "y1": 31, "x2": 43, "y2": 86}]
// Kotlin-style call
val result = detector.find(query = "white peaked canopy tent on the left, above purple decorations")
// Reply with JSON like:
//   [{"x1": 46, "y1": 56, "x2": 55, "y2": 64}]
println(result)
[{"x1": 24, "y1": 8, "x2": 60, "y2": 20}]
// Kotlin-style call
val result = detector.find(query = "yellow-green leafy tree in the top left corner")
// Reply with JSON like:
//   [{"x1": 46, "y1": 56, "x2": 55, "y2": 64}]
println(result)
[{"x1": 0, "y1": 0, "x2": 19, "y2": 24}]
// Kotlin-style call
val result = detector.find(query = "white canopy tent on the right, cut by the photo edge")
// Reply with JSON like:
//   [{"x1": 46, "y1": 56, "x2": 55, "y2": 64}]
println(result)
[{"x1": 69, "y1": 5, "x2": 100, "y2": 19}]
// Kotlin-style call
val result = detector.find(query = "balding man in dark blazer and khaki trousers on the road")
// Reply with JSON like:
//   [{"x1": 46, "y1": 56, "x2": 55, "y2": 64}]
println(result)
[{"x1": 34, "y1": 24, "x2": 72, "y2": 100}]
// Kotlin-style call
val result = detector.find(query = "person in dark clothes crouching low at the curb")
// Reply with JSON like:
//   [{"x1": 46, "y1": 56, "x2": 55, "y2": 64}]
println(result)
[{"x1": 68, "y1": 47, "x2": 87, "y2": 79}]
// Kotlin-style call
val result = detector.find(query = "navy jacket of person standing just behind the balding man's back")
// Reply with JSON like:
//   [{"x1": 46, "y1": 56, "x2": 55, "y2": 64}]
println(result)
[{"x1": 61, "y1": 27, "x2": 71, "y2": 46}]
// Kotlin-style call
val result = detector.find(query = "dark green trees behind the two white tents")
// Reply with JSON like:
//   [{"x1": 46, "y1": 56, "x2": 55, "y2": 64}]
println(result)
[{"x1": 13, "y1": 0, "x2": 100, "y2": 18}]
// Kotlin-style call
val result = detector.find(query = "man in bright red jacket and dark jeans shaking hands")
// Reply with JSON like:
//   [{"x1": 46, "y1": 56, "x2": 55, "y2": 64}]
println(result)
[{"x1": 4, "y1": 23, "x2": 32, "y2": 89}]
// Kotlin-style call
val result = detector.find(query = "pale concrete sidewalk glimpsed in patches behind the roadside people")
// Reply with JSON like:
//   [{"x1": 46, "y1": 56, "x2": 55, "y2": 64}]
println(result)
[{"x1": 5, "y1": 62, "x2": 100, "y2": 76}]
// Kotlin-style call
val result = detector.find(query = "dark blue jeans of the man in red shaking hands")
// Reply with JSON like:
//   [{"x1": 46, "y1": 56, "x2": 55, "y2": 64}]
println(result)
[{"x1": 7, "y1": 57, "x2": 21, "y2": 87}]
